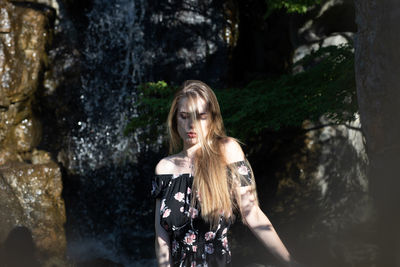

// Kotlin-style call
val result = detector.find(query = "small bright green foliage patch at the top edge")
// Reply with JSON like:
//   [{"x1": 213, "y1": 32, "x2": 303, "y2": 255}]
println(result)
[{"x1": 265, "y1": 0, "x2": 322, "y2": 17}]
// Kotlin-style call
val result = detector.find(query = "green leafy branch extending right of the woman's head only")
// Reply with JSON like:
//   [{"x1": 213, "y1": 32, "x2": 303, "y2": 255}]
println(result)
[{"x1": 222, "y1": 45, "x2": 358, "y2": 140}]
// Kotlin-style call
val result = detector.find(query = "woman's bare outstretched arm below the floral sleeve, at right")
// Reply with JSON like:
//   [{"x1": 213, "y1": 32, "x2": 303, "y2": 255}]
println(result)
[{"x1": 237, "y1": 186, "x2": 297, "y2": 266}]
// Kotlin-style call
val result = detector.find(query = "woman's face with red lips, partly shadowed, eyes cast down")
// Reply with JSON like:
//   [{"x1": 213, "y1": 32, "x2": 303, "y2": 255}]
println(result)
[{"x1": 176, "y1": 97, "x2": 209, "y2": 147}]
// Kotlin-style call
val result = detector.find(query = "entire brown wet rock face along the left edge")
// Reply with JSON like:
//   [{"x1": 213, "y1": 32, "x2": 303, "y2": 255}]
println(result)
[{"x1": 0, "y1": 1, "x2": 65, "y2": 264}]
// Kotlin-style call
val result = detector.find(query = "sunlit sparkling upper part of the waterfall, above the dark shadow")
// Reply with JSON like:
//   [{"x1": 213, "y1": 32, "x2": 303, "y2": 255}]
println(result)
[{"x1": 70, "y1": 0, "x2": 144, "y2": 174}]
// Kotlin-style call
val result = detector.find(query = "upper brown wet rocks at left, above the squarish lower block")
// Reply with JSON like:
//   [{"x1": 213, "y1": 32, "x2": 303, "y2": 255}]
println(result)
[{"x1": 0, "y1": 1, "x2": 52, "y2": 163}]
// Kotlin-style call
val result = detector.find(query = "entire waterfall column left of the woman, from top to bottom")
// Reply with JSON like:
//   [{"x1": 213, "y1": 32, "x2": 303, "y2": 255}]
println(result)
[{"x1": 66, "y1": 0, "x2": 153, "y2": 266}]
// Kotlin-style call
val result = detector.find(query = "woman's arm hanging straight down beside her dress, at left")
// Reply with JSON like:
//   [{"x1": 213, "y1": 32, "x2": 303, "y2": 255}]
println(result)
[{"x1": 155, "y1": 199, "x2": 172, "y2": 267}]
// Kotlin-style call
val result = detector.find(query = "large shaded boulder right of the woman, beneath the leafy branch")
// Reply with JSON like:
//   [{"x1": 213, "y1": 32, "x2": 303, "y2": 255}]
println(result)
[{"x1": 271, "y1": 116, "x2": 378, "y2": 266}]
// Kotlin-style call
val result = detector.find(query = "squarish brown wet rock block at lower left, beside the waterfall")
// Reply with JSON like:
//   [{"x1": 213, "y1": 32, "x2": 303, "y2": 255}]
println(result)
[{"x1": 0, "y1": 163, "x2": 66, "y2": 255}]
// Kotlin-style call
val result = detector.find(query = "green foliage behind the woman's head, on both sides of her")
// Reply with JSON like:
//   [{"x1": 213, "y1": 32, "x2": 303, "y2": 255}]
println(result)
[{"x1": 126, "y1": 45, "x2": 357, "y2": 146}]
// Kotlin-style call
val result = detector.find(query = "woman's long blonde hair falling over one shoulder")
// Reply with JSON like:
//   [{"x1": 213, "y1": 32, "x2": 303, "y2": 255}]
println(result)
[{"x1": 168, "y1": 80, "x2": 254, "y2": 227}]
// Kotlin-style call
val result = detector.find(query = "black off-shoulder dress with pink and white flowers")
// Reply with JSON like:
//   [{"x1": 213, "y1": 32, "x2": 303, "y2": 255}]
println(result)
[{"x1": 151, "y1": 161, "x2": 251, "y2": 267}]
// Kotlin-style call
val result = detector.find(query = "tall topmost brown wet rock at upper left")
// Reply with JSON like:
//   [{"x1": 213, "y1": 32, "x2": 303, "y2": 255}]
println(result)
[{"x1": 1, "y1": 4, "x2": 48, "y2": 103}]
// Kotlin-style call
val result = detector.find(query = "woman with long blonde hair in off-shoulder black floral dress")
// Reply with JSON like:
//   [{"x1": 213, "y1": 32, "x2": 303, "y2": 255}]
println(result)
[{"x1": 152, "y1": 80, "x2": 295, "y2": 266}]
